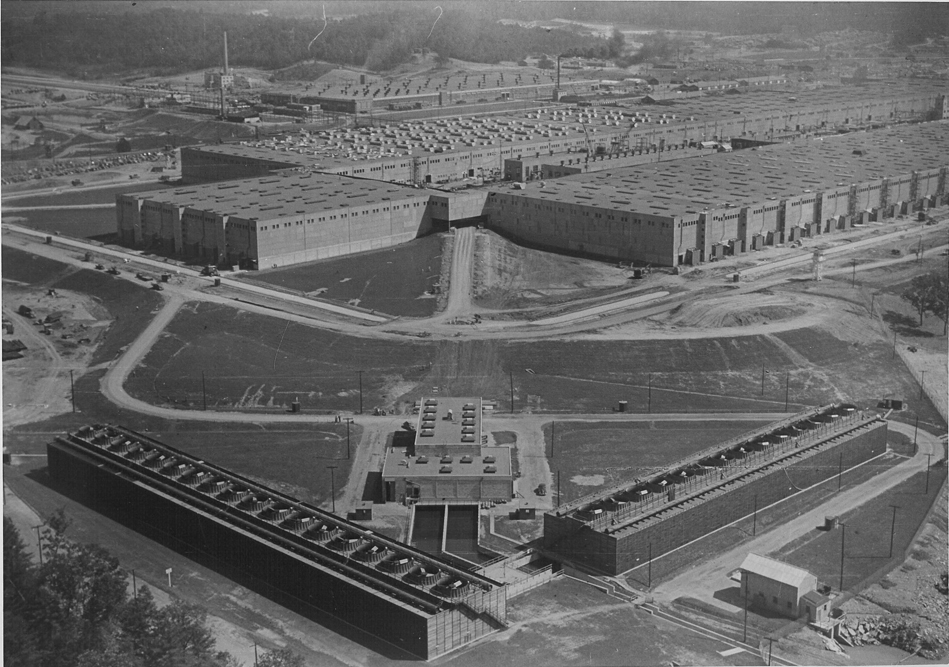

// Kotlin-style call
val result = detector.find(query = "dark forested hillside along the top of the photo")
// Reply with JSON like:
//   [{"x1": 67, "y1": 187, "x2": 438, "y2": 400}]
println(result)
[{"x1": 0, "y1": 3, "x2": 622, "y2": 77}]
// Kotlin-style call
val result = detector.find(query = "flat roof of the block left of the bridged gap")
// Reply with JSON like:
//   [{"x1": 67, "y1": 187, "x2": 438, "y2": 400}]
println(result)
[{"x1": 119, "y1": 172, "x2": 430, "y2": 220}]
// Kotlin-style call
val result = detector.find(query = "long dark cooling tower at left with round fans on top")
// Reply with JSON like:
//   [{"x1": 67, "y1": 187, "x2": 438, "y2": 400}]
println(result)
[{"x1": 47, "y1": 425, "x2": 507, "y2": 660}]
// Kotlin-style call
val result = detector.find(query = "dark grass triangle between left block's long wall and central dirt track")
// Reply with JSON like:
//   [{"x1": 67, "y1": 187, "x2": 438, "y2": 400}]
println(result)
[{"x1": 245, "y1": 234, "x2": 442, "y2": 317}]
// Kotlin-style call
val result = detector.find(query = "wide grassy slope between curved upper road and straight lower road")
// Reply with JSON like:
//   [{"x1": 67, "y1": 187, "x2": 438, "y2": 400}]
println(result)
[{"x1": 128, "y1": 304, "x2": 926, "y2": 420}]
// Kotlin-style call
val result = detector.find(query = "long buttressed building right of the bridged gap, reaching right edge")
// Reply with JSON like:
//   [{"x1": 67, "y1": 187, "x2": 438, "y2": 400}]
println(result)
[{"x1": 485, "y1": 121, "x2": 949, "y2": 266}]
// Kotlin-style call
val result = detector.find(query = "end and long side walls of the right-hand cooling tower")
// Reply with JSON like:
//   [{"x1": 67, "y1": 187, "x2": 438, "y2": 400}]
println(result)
[{"x1": 544, "y1": 422, "x2": 886, "y2": 575}]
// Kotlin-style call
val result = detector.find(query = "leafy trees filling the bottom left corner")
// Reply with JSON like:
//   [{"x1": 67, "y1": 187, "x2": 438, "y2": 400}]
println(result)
[{"x1": 3, "y1": 510, "x2": 303, "y2": 667}]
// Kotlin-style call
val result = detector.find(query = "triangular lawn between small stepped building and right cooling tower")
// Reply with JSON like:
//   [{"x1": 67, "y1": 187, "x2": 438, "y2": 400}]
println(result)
[{"x1": 544, "y1": 421, "x2": 767, "y2": 502}]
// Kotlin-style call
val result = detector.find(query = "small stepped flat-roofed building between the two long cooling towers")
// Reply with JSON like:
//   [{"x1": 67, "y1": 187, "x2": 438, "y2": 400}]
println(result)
[{"x1": 382, "y1": 397, "x2": 514, "y2": 505}]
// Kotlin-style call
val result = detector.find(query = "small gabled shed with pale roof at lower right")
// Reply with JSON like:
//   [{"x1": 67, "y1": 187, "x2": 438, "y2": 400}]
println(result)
[{"x1": 738, "y1": 553, "x2": 817, "y2": 618}]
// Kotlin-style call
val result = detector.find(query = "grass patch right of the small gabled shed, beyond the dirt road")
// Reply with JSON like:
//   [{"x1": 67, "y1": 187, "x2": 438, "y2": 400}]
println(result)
[{"x1": 771, "y1": 461, "x2": 946, "y2": 590}]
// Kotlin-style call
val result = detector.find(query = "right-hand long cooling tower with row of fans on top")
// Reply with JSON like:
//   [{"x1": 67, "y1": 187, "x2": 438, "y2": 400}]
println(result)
[{"x1": 543, "y1": 405, "x2": 887, "y2": 575}]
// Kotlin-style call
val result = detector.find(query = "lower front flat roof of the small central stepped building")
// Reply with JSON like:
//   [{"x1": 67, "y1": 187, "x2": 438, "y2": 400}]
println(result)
[{"x1": 382, "y1": 447, "x2": 511, "y2": 479}]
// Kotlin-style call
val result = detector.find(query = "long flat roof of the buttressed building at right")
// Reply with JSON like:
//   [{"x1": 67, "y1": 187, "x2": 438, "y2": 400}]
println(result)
[{"x1": 493, "y1": 121, "x2": 949, "y2": 217}]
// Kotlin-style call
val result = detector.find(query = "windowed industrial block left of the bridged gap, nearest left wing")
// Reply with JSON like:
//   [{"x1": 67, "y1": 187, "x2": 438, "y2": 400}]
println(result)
[{"x1": 116, "y1": 171, "x2": 433, "y2": 269}]
